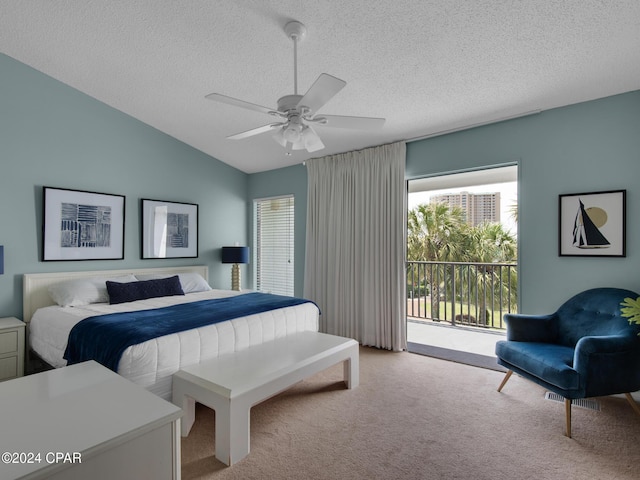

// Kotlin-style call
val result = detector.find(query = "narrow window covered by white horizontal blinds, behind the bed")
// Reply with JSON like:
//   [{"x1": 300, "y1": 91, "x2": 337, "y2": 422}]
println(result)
[{"x1": 254, "y1": 195, "x2": 294, "y2": 296}]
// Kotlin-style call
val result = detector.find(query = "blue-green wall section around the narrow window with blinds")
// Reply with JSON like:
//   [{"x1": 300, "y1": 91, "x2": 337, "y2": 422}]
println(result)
[{"x1": 248, "y1": 165, "x2": 307, "y2": 296}]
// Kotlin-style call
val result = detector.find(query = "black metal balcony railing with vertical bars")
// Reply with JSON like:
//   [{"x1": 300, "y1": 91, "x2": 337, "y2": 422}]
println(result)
[{"x1": 407, "y1": 261, "x2": 518, "y2": 330}]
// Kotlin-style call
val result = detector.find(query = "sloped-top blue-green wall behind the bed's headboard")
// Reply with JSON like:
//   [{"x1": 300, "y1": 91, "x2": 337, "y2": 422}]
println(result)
[{"x1": 0, "y1": 55, "x2": 248, "y2": 317}]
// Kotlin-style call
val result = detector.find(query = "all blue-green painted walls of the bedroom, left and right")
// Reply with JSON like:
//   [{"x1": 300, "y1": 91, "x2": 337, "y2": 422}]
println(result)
[{"x1": 0, "y1": 49, "x2": 640, "y2": 316}]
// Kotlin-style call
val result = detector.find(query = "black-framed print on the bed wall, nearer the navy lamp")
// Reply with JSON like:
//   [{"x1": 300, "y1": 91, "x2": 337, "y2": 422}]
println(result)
[{"x1": 141, "y1": 198, "x2": 198, "y2": 258}]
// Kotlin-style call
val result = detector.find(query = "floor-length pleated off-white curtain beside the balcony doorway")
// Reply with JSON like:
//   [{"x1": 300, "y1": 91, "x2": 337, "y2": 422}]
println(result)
[{"x1": 304, "y1": 142, "x2": 406, "y2": 351}]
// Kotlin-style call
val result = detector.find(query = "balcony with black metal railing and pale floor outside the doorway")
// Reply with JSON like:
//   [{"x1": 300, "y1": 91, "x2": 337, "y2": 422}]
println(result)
[{"x1": 407, "y1": 261, "x2": 518, "y2": 370}]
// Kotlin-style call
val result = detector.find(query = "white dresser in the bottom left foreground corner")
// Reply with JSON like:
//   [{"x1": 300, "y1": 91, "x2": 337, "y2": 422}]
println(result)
[{"x1": 0, "y1": 361, "x2": 182, "y2": 480}]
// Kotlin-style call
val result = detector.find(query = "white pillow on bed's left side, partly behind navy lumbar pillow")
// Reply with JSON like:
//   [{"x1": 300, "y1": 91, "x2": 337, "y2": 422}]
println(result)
[{"x1": 49, "y1": 275, "x2": 137, "y2": 307}]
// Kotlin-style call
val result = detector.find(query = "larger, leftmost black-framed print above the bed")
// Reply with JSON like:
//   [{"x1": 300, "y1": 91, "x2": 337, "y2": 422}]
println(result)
[{"x1": 42, "y1": 187, "x2": 125, "y2": 261}]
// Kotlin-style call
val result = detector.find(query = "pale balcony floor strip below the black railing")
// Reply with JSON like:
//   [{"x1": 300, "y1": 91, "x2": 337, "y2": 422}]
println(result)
[{"x1": 407, "y1": 319, "x2": 505, "y2": 371}]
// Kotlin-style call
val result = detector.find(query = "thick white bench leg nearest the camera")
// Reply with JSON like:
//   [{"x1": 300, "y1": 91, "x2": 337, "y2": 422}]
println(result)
[{"x1": 215, "y1": 401, "x2": 251, "y2": 466}]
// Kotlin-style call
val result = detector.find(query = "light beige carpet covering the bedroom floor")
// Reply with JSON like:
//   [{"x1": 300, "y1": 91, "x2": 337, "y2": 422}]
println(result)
[{"x1": 182, "y1": 347, "x2": 640, "y2": 480}]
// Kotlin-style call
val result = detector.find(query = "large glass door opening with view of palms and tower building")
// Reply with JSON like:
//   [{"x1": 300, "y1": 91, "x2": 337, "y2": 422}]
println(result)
[{"x1": 407, "y1": 164, "x2": 518, "y2": 366}]
